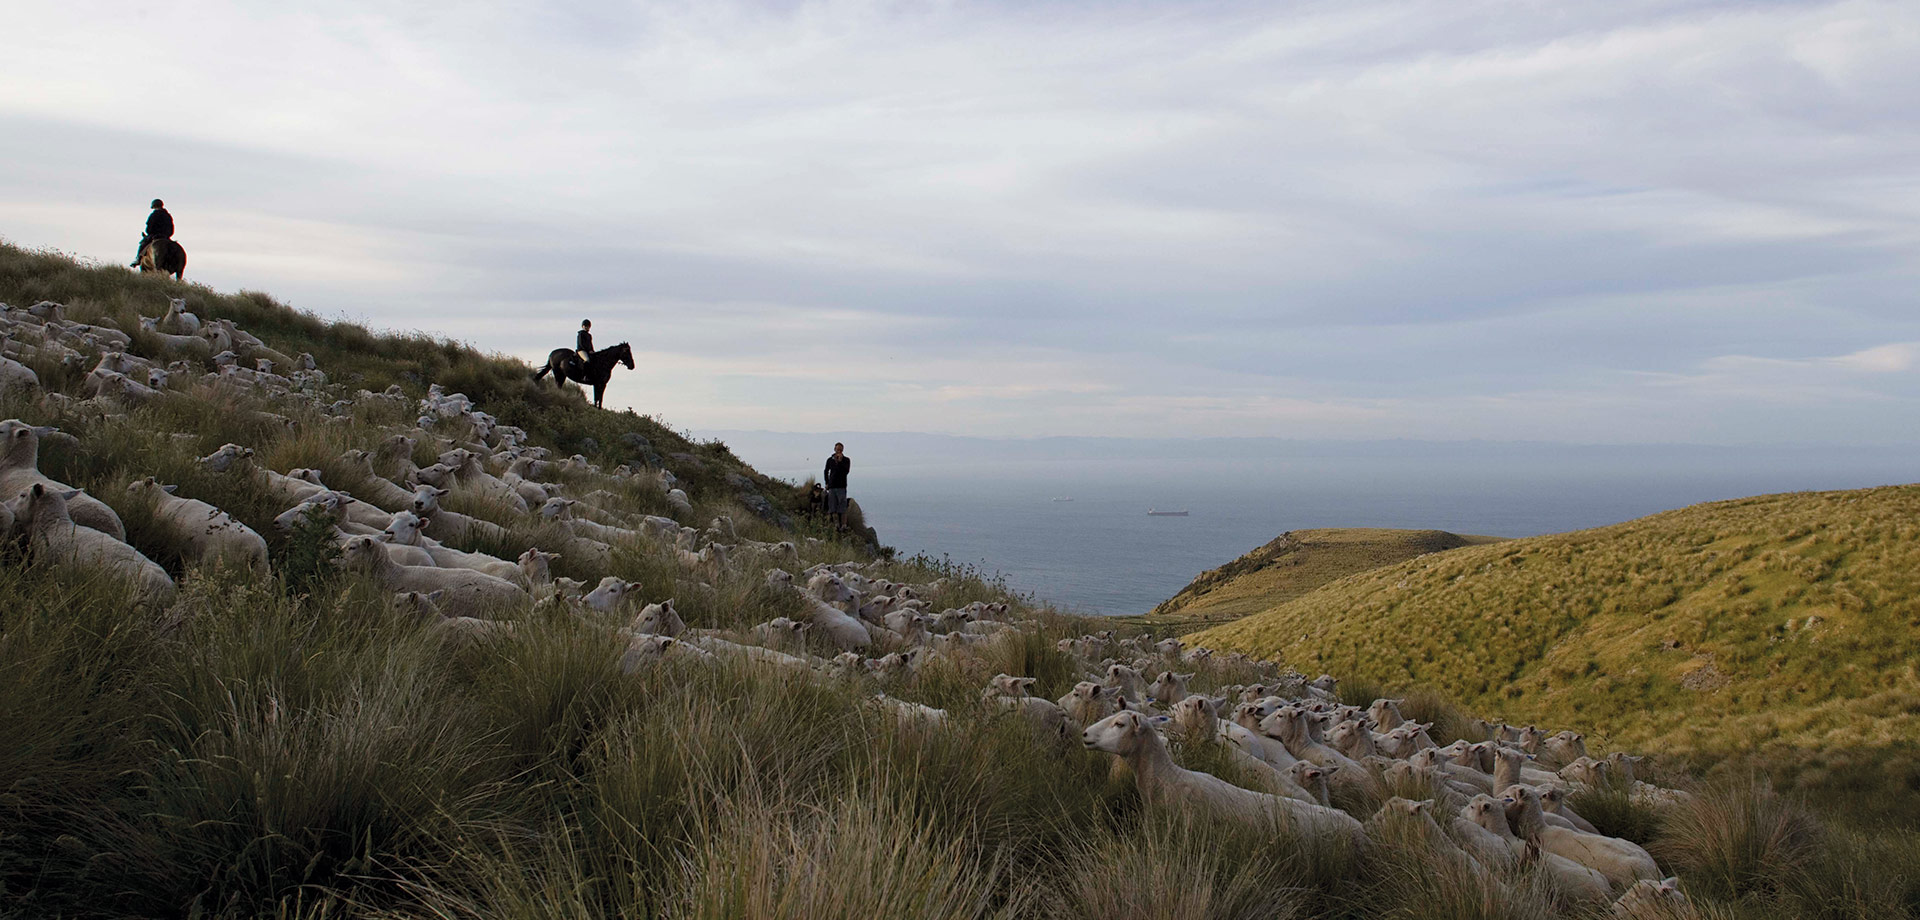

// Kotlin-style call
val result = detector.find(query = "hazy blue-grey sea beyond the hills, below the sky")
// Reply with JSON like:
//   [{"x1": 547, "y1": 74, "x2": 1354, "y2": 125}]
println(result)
[{"x1": 718, "y1": 432, "x2": 1920, "y2": 615}]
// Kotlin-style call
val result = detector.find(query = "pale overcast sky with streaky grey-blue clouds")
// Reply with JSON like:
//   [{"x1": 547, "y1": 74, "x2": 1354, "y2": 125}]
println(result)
[{"x1": 0, "y1": 0, "x2": 1920, "y2": 444}]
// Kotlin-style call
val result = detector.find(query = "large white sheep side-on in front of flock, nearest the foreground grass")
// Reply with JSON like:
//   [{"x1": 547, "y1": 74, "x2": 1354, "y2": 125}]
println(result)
[{"x1": 1083, "y1": 711, "x2": 1365, "y2": 847}]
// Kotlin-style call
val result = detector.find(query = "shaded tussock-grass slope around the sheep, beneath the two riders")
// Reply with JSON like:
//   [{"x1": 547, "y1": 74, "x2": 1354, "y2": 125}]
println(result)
[{"x1": 0, "y1": 248, "x2": 1920, "y2": 920}]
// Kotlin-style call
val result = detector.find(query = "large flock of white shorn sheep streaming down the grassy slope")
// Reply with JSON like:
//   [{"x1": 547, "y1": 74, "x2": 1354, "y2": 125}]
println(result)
[{"x1": 0, "y1": 300, "x2": 1688, "y2": 918}]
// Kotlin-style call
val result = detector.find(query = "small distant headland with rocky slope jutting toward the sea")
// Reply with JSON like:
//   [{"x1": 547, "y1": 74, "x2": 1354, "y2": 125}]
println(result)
[{"x1": 1148, "y1": 528, "x2": 1500, "y2": 626}]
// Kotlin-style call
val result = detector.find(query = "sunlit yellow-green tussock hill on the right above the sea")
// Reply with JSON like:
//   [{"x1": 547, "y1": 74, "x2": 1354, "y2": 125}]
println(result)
[{"x1": 1192, "y1": 486, "x2": 1920, "y2": 825}]
